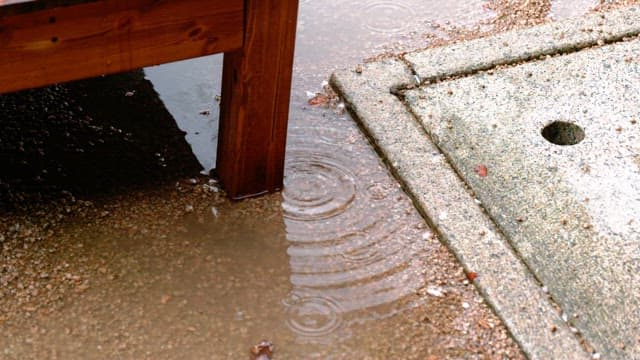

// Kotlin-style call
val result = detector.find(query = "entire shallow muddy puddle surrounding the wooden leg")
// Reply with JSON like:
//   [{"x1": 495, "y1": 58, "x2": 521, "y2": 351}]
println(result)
[{"x1": 0, "y1": 0, "x2": 594, "y2": 359}]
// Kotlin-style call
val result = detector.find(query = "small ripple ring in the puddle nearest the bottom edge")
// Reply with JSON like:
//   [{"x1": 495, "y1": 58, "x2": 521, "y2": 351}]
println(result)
[{"x1": 285, "y1": 295, "x2": 343, "y2": 340}]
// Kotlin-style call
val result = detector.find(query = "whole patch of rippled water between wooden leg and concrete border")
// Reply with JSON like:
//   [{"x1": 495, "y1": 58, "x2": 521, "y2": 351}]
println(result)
[{"x1": 282, "y1": 126, "x2": 424, "y2": 342}]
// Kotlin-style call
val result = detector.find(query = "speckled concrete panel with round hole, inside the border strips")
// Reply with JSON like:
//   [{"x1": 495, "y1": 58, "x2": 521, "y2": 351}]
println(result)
[{"x1": 407, "y1": 40, "x2": 640, "y2": 358}]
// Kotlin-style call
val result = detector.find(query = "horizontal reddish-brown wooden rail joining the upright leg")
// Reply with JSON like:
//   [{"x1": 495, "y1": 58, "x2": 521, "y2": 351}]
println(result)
[{"x1": 0, "y1": 0, "x2": 245, "y2": 93}]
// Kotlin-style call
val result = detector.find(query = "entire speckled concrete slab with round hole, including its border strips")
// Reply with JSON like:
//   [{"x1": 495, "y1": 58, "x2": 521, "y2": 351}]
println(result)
[{"x1": 332, "y1": 7, "x2": 640, "y2": 359}]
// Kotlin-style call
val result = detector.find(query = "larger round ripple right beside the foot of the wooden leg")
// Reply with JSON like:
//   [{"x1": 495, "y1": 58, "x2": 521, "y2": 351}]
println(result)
[{"x1": 282, "y1": 150, "x2": 356, "y2": 220}]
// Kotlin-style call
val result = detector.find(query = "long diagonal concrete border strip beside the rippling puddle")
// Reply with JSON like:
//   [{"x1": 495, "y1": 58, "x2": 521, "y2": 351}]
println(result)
[{"x1": 330, "y1": 60, "x2": 591, "y2": 359}]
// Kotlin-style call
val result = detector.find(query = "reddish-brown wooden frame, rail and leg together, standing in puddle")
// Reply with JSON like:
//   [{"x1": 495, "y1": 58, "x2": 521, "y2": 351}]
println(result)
[{"x1": 0, "y1": 0, "x2": 298, "y2": 199}]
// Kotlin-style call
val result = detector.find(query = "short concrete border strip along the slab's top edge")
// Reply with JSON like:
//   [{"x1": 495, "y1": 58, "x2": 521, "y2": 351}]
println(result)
[{"x1": 404, "y1": 6, "x2": 640, "y2": 82}]
